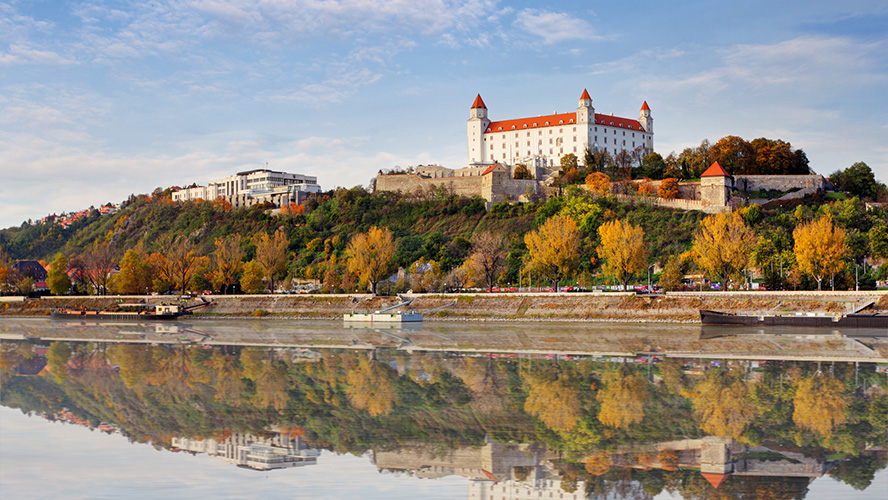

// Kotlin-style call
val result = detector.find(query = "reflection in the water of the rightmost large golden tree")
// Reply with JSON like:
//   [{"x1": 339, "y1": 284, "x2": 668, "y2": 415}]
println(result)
[{"x1": 792, "y1": 373, "x2": 848, "y2": 437}]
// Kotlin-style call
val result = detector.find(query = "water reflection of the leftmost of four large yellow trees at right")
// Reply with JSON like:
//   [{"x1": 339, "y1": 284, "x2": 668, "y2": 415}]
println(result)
[{"x1": 524, "y1": 374, "x2": 580, "y2": 431}]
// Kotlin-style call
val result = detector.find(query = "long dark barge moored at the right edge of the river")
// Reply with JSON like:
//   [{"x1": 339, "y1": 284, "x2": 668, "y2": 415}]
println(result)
[{"x1": 700, "y1": 309, "x2": 888, "y2": 329}]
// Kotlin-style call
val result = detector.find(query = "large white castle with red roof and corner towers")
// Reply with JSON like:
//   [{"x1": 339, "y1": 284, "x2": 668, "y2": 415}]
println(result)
[{"x1": 468, "y1": 90, "x2": 654, "y2": 167}]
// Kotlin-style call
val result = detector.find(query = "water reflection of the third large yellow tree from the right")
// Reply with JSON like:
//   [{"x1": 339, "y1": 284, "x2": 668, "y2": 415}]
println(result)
[{"x1": 595, "y1": 365, "x2": 648, "y2": 429}]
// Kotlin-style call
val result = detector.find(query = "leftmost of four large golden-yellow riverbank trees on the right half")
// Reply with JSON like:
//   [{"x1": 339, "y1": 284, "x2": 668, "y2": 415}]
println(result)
[{"x1": 524, "y1": 216, "x2": 580, "y2": 291}]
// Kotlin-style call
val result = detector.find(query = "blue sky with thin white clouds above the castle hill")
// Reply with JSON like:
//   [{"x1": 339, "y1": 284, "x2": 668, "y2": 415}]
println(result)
[{"x1": 0, "y1": 0, "x2": 888, "y2": 227}]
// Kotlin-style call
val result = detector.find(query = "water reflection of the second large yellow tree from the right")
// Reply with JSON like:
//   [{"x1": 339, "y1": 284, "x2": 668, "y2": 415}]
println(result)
[{"x1": 686, "y1": 368, "x2": 757, "y2": 439}]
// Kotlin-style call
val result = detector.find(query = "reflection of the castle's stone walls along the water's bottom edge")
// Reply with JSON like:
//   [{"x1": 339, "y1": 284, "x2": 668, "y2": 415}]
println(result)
[{"x1": 374, "y1": 436, "x2": 831, "y2": 500}]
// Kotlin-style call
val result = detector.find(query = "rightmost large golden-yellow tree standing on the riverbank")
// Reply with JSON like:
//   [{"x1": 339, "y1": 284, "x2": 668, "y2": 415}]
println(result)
[{"x1": 792, "y1": 214, "x2": 848, "y2": 290}]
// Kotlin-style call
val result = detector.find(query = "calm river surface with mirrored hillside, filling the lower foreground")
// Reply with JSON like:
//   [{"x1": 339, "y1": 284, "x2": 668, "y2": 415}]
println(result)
[{"x1": 0, "y1": 320, "x2": 888, "y2": 499}]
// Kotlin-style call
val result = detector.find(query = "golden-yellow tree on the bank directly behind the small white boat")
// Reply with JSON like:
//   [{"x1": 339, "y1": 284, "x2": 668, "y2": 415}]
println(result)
[{"x1": 345, "y1": 226, "x2": 397, "y2": 295}]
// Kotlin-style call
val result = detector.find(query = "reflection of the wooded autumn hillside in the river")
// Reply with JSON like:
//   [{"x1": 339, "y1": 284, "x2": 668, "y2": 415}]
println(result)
[{"x1": 0, "y1": 341, "x2": 888, "y2": 498}]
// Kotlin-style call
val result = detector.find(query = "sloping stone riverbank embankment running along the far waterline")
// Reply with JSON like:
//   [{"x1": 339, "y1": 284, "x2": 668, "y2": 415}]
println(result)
[{"x1": 0, "y1": 290, "x2": 888, "y2": 323}]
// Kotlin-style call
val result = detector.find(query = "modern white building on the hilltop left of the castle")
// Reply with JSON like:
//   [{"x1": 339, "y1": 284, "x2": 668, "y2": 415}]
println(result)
[{"x1": 173, "y1": 169, "x2": 321, "y2": 201}]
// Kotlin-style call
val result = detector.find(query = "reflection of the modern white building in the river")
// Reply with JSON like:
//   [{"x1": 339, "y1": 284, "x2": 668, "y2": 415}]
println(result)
[{"x1": 172, "y1": 433, "x2": 321, "y2": 470}]
